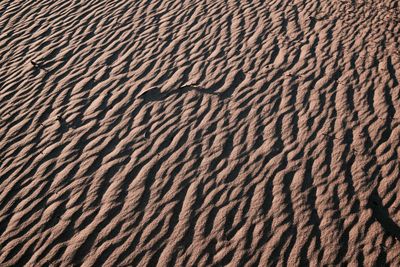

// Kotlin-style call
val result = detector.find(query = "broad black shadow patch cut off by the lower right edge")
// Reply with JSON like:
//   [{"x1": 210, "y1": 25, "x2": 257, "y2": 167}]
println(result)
[{"x1": 368, "y1": 189, "x2": 400, "y2": 241}]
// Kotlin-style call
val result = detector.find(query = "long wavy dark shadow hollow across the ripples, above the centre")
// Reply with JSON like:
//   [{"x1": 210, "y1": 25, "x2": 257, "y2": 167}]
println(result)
[{"x1": 139, "y1": 85, "x2": 221, "y2": 102}]
